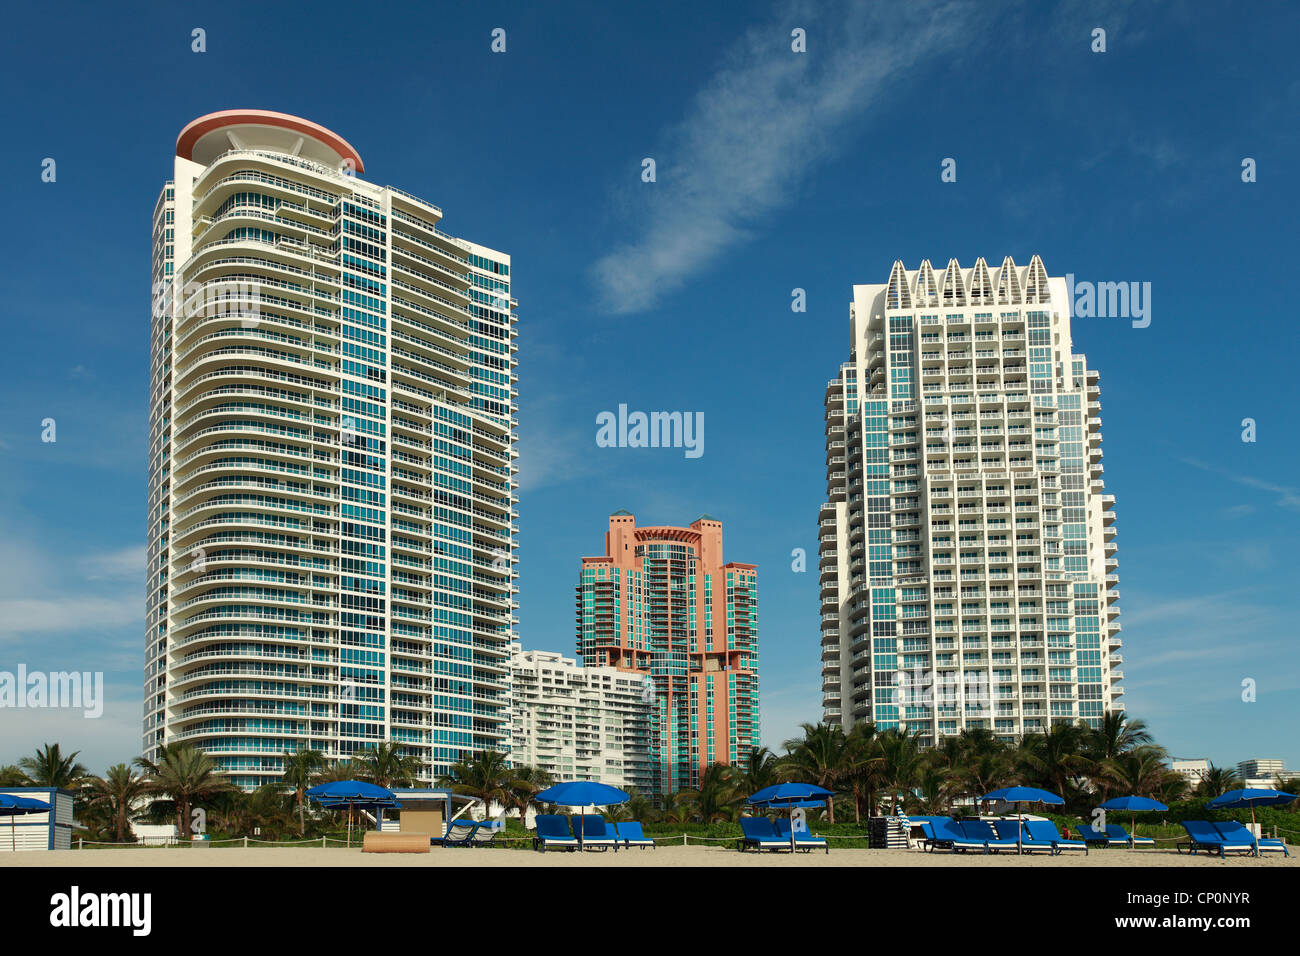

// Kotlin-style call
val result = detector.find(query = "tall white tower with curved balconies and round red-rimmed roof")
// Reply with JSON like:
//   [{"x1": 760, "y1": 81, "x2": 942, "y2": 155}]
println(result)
[{"x1": 144, "y1": 109, "x2": 516, "y2": 787}]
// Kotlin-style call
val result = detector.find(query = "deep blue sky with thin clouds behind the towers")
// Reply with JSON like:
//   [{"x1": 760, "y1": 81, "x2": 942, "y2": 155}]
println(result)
[{"x1": 0, "y1": 3, "x2": 1300, "y2": 770}]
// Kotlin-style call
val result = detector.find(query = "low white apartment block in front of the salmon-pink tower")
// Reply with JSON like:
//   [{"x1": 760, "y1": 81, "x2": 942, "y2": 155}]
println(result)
[{"x1": 510, "y1": 645, "x2": 654, "y2": 792}]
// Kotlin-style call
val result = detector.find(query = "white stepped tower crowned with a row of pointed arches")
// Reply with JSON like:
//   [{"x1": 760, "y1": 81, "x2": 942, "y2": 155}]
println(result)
[{"x1": 819, "y1": 256, "x2": 1123, "y2": 743}]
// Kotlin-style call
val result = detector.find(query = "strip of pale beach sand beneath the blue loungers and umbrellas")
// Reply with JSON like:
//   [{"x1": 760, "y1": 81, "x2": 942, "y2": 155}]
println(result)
[{"x1": 0, "y1": 844, "x2": 1300, "y2": 869}]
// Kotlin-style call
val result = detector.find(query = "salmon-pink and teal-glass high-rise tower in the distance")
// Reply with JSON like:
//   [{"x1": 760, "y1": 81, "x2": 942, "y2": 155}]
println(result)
[{"x1": 577, "y1": 511, "x2": 759, "y2": 793}]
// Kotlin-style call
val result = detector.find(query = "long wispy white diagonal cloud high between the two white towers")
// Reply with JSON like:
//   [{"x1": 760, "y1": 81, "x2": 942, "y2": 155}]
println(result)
[{"x1": 592, "y1": 4, "x2": 978, "y2": 312}]
